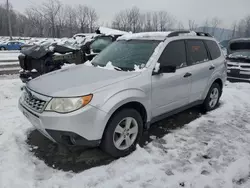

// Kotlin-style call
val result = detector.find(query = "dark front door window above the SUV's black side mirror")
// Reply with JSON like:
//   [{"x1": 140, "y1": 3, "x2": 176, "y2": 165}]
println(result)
[{"x1": 158, "y1": 40, "x2": 187, "y2": 68}]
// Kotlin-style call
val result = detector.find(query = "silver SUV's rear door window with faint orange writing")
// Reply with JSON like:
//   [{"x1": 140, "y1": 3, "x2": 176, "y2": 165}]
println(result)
[{"x1": 187, "y1": 40, "x2": 209, "y2": 65}]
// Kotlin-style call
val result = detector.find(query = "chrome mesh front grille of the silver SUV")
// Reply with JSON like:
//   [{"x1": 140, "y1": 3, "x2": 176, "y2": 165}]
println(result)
[{"x1": 24, "y1": 92, "x2": 46, "y2": 112}]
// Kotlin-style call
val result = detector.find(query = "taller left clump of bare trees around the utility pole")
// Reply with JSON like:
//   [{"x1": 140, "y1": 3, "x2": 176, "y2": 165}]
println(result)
[{"x1": 0, "y1": 0, "x2": 98, "y2": 37}]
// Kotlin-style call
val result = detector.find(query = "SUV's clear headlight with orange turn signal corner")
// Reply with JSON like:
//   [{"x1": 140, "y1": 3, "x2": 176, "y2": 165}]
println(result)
[{"x1": 45, "y1": 95, "x2": 93, "y2": 113}]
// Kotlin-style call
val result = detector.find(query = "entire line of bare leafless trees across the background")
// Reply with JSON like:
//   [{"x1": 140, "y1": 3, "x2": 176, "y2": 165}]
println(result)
[{"x1": 0, "y1": 0, "x2": 250, "y2": 38}]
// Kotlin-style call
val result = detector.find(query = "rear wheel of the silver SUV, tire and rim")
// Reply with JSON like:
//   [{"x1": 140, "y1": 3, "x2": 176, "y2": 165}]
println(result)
[{"x1": 203, "y1": 83, "x2": 222, "y2": 112}]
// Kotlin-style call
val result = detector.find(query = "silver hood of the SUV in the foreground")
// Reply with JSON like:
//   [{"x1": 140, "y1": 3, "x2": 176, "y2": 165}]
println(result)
[{"x1": 27, "y1": 65, "x2": 140, "y2": 97}]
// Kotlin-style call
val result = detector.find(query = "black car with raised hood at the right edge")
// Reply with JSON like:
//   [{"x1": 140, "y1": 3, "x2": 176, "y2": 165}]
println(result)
[{"x1": 227, "y1": 38, "x2": 250, "y2": 82}]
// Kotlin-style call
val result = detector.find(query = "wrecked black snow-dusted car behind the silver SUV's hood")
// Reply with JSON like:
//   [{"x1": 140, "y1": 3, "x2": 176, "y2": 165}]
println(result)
[{"x1": 18, "y1": 29, "x2": 127, "y2": 83}]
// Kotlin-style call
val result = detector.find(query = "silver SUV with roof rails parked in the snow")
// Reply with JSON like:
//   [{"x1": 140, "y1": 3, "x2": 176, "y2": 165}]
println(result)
[{"x1": 19, "y1": 31, "x2": 227, "y2": 157}]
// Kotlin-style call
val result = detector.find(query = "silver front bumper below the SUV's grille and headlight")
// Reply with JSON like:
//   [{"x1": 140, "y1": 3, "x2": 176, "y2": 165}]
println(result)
[{"x1": 19, "y1": 101, "x2": 106, "y2": 147}]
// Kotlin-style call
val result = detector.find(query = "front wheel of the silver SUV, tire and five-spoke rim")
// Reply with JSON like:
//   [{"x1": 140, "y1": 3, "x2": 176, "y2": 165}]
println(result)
[{"x1": 100, "y1": 109, "x2": 143, "y2": 158}]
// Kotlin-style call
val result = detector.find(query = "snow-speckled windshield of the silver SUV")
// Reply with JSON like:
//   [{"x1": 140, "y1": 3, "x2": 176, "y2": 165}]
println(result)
[{"x1": 92, "y1": 40, "x2": 159, "y2": 71}]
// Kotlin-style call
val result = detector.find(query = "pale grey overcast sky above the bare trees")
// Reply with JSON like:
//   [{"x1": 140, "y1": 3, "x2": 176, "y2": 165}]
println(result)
[{"x1": 4, "y1": 0, "x2": 250, "y2": 28}]
